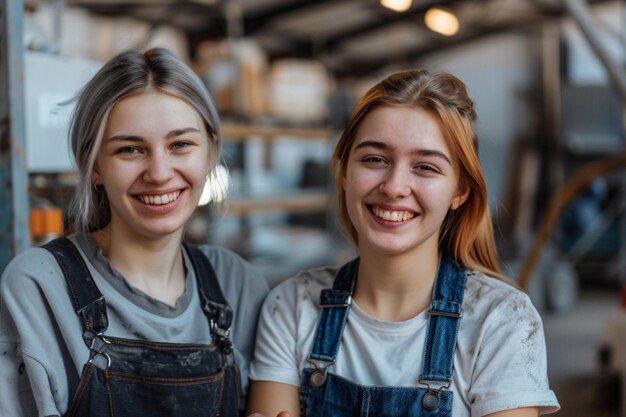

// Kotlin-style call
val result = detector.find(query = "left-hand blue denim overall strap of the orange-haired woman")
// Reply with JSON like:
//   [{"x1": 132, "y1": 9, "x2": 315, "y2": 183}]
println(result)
[{"x1": 309, "y1": 258, "x2": 359, "y2": 366}]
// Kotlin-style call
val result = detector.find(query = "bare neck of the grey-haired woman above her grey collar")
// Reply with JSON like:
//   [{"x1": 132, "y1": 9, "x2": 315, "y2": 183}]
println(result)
[{"x1": 93, "y1": 225, "x2": 186, "y2": 306}]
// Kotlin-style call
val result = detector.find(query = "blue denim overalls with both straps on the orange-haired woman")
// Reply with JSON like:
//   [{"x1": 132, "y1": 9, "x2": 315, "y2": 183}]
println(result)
[{"x1": 300, "y1": 255, "x2": 465, "y2": 417}]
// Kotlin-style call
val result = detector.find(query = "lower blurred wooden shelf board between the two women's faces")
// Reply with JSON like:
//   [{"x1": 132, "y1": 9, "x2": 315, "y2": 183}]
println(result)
[{"x1": 224, "y1": 191, "x2": 330, "y2": 216}]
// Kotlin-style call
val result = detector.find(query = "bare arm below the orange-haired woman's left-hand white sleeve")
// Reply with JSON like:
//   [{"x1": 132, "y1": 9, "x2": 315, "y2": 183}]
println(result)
[{"x1": 248, "y1": 381, "x2": 300, "y2": 417}]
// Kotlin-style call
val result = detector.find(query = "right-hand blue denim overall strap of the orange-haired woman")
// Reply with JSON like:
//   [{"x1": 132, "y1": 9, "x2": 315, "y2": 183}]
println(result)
[{"x1": 420, "y1": 253, "x2": 466, "y2": 387}]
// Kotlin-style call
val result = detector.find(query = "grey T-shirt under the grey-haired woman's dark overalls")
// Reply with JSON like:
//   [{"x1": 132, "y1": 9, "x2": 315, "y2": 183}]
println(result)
[{"x1": 0, "y1": 235, "x2": 268, "y2": 417}]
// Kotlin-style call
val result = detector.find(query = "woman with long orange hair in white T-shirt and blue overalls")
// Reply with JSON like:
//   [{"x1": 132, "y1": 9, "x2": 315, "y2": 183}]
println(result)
[{"x1": 248, "y1": 70, "x2": 558, "y2": 417}]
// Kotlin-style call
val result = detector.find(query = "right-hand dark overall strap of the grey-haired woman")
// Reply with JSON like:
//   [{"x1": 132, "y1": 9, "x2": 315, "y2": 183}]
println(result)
[{"x1": 183, "y1": 243, "x2": 233, "y2": 354}]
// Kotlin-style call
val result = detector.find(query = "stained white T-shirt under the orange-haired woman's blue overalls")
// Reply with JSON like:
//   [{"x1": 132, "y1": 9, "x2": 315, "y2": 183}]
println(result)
[{"x1": 250, "y1": 268, "x2": 559, "y2": 417}]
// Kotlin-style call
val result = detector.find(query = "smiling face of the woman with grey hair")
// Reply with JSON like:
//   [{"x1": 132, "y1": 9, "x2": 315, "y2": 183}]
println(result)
[{"x1": 92, "y1": 91, "x2": 210, "y2": 238}]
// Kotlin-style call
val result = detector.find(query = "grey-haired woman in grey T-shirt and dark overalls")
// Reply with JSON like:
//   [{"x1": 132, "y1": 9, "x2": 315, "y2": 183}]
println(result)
[{"x1": 0, "y1": 48, "x2": 267, "y2": 417}]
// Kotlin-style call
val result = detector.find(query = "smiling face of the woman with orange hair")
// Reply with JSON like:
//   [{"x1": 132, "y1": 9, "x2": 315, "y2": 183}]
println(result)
[{"x1": 344, "y1": 106, "x2": 467, "y2": 255}]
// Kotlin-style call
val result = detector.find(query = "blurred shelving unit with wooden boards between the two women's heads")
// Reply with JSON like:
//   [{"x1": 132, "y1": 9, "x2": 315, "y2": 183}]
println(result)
[{"x1": 207, "y1": 118, "x2": 336, "y2": 285}]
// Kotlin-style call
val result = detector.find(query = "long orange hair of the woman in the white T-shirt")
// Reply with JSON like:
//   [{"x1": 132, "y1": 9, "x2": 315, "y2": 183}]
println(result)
[{"x1": 331, "y1": 70, "x2": 504, "y2": 278}]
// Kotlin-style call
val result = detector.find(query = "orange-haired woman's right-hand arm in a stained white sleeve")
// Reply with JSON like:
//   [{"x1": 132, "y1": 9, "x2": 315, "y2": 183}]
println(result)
[{"x1": 461, "y1": 287, "x2": 558, "y2": 417}]
